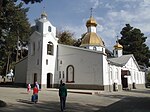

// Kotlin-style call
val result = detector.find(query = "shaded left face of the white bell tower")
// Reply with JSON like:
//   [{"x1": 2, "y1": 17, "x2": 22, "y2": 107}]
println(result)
[{"x1": 27, "y1": 32, "x2": 42, "y2": 84}]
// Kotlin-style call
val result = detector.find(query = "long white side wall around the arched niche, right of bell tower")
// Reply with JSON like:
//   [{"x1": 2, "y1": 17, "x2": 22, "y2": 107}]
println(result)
[{"x1": 55, "y1": 44, "x2": 103, "y2": 85}]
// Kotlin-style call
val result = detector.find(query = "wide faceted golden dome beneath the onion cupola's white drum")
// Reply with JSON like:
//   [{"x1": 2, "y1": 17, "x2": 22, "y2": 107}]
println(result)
[{"x1": 81, "y1": 32, "x2": 104, "y2": 46}]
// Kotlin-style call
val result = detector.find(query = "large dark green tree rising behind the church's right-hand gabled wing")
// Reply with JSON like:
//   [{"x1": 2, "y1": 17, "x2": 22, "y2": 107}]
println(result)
[{"x1": 119, "y1": 24, "x2": 150, "y2": 67}]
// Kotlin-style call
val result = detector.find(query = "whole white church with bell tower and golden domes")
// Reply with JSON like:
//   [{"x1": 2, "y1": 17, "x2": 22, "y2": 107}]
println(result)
[{"x1": 15, "y1": 13, "x2": 145, "y2": 91}]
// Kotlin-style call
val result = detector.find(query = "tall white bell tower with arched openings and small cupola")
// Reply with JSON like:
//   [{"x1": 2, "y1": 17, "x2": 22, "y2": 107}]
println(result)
[{"x1": 27, "y1": 12, "x2": 58, "y2": 88}]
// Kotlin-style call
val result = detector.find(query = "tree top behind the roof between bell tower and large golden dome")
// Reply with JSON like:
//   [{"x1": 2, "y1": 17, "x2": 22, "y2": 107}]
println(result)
[{"x1": 57, "y1": 31, "x2": 76, "y2": 45}]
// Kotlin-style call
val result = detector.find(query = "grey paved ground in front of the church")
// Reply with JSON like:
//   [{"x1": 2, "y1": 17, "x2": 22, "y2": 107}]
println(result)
[{"x1": 0, "y1": 87, "x2": 150, "y2": 112}]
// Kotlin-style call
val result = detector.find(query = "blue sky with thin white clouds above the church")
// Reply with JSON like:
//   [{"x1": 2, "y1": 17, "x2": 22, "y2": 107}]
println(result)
[{"x1": 21, "y1": 0, "x2": 150, "y2": 50}]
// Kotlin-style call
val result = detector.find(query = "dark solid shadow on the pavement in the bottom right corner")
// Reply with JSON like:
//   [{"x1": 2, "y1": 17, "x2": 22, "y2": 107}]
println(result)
[{"x1": 95, "y1": 97, "x2": 150, "y2": 112}]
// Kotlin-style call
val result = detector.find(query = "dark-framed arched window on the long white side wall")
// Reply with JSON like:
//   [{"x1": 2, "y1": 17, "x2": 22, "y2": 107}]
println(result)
[{"x1": 66, "y1": 65, "x2": 74, "y2": 83}]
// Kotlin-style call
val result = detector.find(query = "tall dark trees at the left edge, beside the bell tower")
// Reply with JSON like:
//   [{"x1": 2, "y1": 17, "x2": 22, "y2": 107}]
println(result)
[{"x1": 0, "y1": 0, "x2": 30, "y2": 74}]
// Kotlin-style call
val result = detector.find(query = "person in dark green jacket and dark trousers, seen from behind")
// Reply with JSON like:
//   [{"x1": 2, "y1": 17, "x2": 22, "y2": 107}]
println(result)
[{"x1": 59, "y1": 83, "x2": 67, "y2": 112}]
